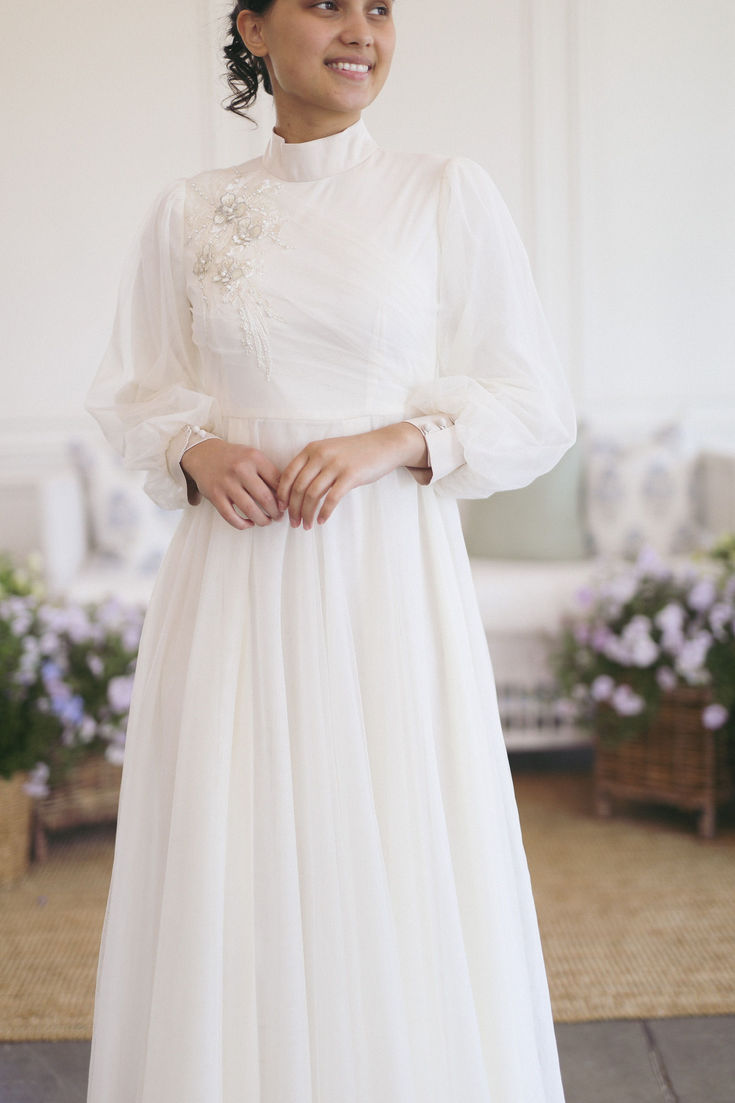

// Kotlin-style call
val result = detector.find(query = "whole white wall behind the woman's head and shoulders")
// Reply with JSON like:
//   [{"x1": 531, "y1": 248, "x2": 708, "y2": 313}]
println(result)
[{"x1": 0, "y1": 0, "x2": 735, "y2": 447}]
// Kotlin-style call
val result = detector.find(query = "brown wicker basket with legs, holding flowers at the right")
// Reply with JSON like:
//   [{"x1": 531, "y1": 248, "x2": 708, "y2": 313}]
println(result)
[{"x1": 595, "y1": 686, "x2": 733, "y2": 838}]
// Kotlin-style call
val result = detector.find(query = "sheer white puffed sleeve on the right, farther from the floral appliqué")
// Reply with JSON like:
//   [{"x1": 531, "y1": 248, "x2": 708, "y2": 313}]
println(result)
[{"x1": 408, "y1": 158, "x2": 577, "y2": 497}]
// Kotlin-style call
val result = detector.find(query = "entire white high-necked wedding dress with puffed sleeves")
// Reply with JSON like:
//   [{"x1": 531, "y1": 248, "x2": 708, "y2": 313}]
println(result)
[{"x1": 82, "y1": 121, "x2": 576, "y2": 1103}]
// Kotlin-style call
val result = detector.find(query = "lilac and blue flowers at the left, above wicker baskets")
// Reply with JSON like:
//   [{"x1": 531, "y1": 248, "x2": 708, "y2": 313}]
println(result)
[{"x1": 0, "y1": 556, "x2": 143, "y2": 796}]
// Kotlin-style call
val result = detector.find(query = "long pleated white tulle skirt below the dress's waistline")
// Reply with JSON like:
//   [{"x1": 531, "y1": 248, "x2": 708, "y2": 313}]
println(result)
[{"x1": 87, "y1": 417, "x2": 563, "y2": 1103}]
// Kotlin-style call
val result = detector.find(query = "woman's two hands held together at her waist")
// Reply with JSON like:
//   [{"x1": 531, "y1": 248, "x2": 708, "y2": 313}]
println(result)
[{"x1": 181, "y1": 421, "x2": 427, "y2": 529}]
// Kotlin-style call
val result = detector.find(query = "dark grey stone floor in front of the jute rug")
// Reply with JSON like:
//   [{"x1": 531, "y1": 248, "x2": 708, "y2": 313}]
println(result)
[{"x1": 0, "y1": 1016, "x2": 735, "y2": 1103}]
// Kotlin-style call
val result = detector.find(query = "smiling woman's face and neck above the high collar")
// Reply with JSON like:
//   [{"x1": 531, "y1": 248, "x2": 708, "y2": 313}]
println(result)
[{"x1": 237, "y1": 0, "x2": 395, "y2": 141}]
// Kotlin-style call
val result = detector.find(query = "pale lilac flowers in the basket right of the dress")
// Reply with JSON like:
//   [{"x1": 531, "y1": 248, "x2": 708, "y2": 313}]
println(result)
[{"x1": 551, "y1": 534, "x2": 735, "y2": 741}]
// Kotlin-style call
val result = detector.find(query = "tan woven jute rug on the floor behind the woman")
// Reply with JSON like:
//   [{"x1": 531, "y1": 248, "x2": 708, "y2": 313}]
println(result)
[{"x1": 0, "y1": 770, "x2": 735, "y2": 1041}]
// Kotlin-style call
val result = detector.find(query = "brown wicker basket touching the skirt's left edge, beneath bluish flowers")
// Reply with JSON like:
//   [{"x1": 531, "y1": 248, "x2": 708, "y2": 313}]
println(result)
[{"x1": 33, "y1": 754, "x2": 123, "y2": 861}]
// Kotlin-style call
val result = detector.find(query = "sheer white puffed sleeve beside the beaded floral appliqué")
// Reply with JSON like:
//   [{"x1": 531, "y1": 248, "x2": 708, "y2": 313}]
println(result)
[{"x1": 85, "y1": 180, "x2": 219, "y2": 510}]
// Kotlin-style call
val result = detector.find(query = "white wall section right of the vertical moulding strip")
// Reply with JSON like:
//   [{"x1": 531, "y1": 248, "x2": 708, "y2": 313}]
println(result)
[{"x1": 578, "y1": 0, "x2": 735, "y2": 434}]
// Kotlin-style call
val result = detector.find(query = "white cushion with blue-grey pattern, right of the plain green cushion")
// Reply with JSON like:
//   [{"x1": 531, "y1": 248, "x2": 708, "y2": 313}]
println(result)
[{"x1": 585, "y1": 422, "x2": 702, "y2": 559}]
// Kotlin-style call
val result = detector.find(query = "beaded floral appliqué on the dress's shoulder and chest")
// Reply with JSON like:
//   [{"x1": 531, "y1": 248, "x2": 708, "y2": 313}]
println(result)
[{"x1": 189, "y1": 169, "x2": 284, "y2": 379}]
